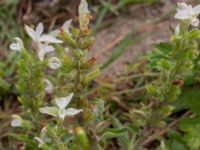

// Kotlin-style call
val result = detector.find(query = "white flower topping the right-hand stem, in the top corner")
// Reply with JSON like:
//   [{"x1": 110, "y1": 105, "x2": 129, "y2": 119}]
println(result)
[{"x1": 175, "y1": 3, "x2": 200, "y2": 26}]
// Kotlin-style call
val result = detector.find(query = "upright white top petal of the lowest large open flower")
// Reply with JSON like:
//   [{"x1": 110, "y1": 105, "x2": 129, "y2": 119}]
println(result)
[{"x1": 55, "y1": 93, "x2": 74, "y2": 109}]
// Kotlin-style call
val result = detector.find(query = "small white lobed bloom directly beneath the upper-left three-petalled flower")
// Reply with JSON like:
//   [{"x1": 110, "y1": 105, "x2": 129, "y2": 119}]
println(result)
[{"x1": 38, "y1": 44, "x2": 55, "y2": 61}]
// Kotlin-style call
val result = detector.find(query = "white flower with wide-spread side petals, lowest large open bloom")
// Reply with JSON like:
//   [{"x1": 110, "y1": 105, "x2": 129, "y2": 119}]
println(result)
[{"x1": 39, "y1": 93, "x2": 83, "y2": 120}]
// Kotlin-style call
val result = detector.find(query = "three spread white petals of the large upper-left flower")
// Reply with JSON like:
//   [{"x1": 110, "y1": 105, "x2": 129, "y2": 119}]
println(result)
[{"x1": 25, "y1": 23, "x2": 62, "y2": 44}]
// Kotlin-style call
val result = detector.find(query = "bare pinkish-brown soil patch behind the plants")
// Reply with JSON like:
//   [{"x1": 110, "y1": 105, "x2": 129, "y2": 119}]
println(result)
[{"x1": 91, "y1": 0, "x2": 194, "y2": 77}]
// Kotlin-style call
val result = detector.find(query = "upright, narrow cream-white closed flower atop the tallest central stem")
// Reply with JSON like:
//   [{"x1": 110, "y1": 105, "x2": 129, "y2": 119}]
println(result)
[{"x1": 78, "y1": 0, "x2": 90, "y2": 30}]
